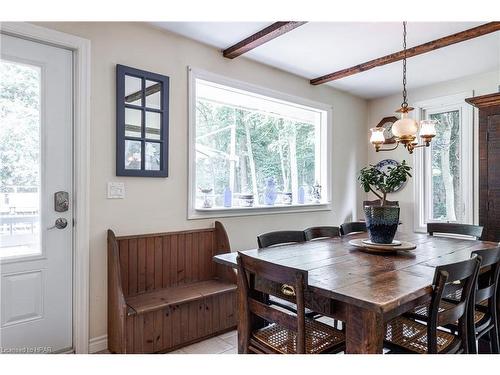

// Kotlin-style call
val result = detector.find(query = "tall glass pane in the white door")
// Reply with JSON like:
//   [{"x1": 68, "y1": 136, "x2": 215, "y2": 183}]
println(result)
[{"x1": 0, "y1": 60, "x2": 41, "y2": 258}]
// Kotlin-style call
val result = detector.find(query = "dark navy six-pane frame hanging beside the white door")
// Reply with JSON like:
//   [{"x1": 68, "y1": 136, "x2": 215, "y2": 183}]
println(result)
[{"x1": 116, "y1": 64, "x2": 170, "y2": 177}]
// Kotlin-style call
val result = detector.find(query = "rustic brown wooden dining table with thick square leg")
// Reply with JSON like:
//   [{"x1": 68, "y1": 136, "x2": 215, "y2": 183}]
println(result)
[{"x1": 214, "y1": 233, "x2": 498, "y2": 353}]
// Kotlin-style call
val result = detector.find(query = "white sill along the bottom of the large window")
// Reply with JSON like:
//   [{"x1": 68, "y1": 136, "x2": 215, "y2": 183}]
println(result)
[{"x1": 188, "y1": 202, "x2": 332, "y2": 220}]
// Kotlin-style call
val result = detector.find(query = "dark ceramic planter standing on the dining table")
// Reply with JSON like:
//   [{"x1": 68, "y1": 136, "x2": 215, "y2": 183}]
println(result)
[{"x1": 364, "y1": 206, "x2": 399, "y2": 244}]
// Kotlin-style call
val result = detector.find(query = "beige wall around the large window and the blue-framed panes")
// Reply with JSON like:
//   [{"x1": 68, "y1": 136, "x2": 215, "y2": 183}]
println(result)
[{"x1": 37, "y1": 23, "x2": 367, "y2": 338}]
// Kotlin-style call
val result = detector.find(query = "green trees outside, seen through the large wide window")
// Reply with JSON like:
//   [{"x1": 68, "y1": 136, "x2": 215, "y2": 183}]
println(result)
[{"x1": 196, "y1": 98, "x2": 315, "y2": 205}]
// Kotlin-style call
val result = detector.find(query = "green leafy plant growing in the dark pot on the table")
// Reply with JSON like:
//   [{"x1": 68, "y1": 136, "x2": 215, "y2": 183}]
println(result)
[{"x1": 358, "y1": 160, "x2": 411, "y2": 206}]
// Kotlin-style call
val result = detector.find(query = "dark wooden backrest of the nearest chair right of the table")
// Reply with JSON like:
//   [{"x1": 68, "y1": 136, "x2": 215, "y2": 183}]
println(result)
[{"x1": 427, "y1": 256, "x2": 481, "y2": 353}]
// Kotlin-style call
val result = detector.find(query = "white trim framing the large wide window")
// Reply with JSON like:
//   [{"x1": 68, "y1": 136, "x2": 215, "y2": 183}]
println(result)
[{"x1": 187, "y1": 67, "x2": 333, "y2": 219}]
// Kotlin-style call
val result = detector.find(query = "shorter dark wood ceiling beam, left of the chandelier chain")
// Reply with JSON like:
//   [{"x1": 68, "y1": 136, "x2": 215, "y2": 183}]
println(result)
[{"x1": 222, "y1": 21, "x2": 306, "y2": 59}]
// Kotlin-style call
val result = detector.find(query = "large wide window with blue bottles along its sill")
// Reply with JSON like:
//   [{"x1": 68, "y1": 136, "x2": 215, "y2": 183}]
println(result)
[{"x1": 190, "y1": 69, "x2": 331, "y2": 217}]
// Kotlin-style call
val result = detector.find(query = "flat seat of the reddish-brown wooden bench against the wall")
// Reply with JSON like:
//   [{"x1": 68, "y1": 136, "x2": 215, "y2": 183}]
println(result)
[{"x1": 125, "y1": 280, "x2": 236, "y2": 315}]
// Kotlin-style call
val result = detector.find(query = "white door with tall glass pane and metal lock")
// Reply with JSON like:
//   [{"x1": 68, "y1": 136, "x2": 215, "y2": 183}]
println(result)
[{"x1": 0, "y1": 35, "x2": 73, "y2": 353}]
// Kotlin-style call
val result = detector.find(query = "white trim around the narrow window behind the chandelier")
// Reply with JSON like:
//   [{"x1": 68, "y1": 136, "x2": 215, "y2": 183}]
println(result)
[{"x1": 413, "y1": 91, "x2": 475, "y2": 233}]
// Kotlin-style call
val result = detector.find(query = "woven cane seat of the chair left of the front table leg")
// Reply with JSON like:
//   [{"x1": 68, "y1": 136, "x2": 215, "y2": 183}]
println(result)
[{"x1": 252, "y1": 319, "x2": 345, "y2": 354}]
